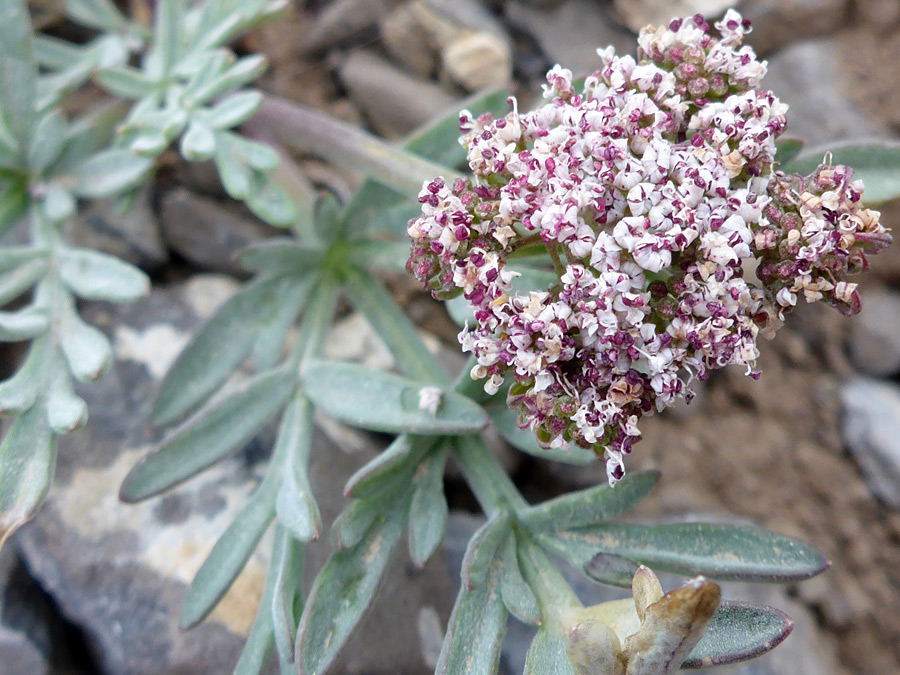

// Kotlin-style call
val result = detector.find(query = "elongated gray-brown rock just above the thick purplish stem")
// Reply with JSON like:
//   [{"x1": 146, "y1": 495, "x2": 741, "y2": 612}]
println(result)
[{"x1": 338, "y1": 50, "x2": 457, "y2": 138}]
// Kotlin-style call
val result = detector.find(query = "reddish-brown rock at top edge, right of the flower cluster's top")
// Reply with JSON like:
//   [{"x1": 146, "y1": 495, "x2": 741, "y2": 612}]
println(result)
[{"x1": 726, "y1": 0, "x2": 847, "y2": 54}]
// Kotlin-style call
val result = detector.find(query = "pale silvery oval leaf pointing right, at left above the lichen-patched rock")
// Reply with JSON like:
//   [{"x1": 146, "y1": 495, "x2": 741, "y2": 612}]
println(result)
[{"x1": 59, "y1": 248, "x2": 150, "y2": 302}]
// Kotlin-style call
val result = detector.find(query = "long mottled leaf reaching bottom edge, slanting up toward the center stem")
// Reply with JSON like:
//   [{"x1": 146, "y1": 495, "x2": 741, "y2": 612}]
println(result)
[{"x1": 295, "y1": 493, "x2": 409, "y2": 675}]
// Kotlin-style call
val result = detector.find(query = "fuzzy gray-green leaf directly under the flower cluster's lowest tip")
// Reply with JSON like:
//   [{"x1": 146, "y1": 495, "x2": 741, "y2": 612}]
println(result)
[{"x1": 520, "y1": 471, "x2": 659, "y2": 531}]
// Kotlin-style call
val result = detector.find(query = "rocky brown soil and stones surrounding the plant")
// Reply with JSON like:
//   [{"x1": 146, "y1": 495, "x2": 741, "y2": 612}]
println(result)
[{"x1": 0, "y1": 0, "x2": 900, "y2": 675}]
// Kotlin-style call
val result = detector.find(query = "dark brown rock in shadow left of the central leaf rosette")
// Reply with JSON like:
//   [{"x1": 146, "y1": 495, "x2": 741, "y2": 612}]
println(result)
[{"x1": 159, "y1": 188, "x2": 283, "y2": 277}]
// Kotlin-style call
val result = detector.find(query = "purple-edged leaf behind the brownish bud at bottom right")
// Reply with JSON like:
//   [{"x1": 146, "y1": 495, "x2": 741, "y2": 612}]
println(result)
[{"x1": 682, "y1": 600, "x2": 794, "y2": 668}]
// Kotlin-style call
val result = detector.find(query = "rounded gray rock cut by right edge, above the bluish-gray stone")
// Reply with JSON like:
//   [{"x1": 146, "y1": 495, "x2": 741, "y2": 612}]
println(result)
[{"x1": 849, "y1": 289, "x2": 900, "y2": 377}]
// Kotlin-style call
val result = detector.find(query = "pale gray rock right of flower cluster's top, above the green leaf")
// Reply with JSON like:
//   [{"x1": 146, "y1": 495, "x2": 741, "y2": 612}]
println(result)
[{"x1": 763, "y1": 38, "x2": 884, "y2": 145}]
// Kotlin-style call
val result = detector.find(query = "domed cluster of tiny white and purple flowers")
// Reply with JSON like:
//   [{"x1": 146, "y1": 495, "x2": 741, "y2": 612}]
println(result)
[{"x1": 408, "y1": 11, "x2": 891, "y2": 483}]
